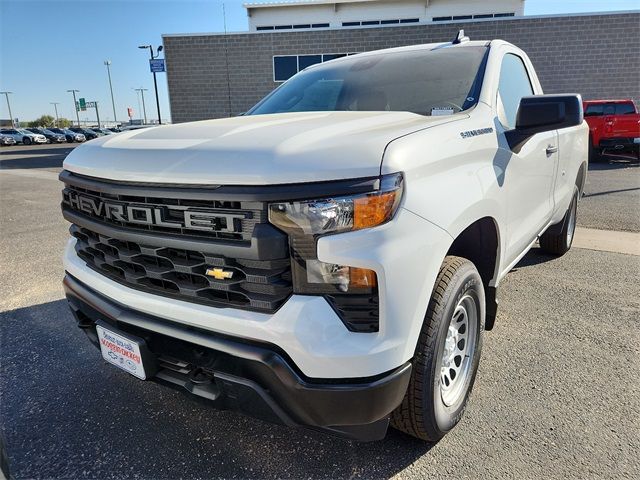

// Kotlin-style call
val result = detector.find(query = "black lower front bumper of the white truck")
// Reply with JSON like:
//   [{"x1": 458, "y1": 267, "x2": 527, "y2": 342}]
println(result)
[{"x1": 64, "y1": 274, "x2": 411, "y2": 441}]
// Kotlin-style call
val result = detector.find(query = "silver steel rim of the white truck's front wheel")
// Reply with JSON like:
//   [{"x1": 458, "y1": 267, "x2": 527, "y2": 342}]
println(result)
[{"x1": 440, "y1": 295, "x2": 478, "y2": 407}]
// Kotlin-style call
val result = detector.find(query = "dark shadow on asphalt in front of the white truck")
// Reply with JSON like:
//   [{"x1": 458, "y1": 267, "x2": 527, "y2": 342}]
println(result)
[{"x1": 0, "y1": 300, "x2": 433, "y2": 478}]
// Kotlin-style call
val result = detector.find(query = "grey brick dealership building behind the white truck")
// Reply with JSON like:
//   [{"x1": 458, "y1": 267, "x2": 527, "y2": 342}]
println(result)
[{"x1": 163, "y1": 0, "x2": 640, "y2": 123}]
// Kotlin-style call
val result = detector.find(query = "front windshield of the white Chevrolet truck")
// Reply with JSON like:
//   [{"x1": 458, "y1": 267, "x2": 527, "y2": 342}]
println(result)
[{"x1": 247, "y1": 47, "x2": 487, "y2": 115}]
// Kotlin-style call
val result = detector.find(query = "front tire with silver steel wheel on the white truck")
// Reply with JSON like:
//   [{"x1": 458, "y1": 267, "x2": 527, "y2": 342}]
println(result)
[{"x1": 391, "y1": 256, "x2": 486, "y2": 442}]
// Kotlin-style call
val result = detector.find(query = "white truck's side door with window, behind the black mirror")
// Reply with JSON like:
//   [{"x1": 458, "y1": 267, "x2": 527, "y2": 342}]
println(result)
[{"x1": 496, "y1": 53, "x2": 558, "y2": 263}]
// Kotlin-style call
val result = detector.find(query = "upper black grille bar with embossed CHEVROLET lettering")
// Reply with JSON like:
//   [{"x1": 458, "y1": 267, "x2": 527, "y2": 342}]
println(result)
[{"x1": 62, "y1": 184, "x2": 267, "y2": 242}]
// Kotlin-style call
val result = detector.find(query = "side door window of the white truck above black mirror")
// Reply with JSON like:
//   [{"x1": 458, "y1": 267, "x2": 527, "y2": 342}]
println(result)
[{"x1": 498, "y1": 53, "x2": 533, "y2": 128}]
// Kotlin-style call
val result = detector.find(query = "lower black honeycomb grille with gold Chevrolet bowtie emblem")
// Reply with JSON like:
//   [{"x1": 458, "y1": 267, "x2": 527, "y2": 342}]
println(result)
[{"x1": 70, "y1": 225, "x2": 292, "y2": 313}]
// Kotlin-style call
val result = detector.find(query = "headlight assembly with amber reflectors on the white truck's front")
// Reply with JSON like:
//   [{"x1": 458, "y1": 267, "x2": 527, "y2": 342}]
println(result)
[{"x1": 269, "y1": 174, "x2": 403, "y2": 332}]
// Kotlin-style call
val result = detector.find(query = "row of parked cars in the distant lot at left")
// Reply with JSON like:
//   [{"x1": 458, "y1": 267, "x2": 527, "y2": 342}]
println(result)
[{"x1": 0, "y1": 127, "x2": 121, "y2": 146}]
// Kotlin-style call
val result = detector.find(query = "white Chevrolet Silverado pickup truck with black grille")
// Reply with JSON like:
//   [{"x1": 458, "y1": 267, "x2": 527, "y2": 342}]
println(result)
[{"x1": 60, "y1": 34, "x2": 588, "y2": 441}]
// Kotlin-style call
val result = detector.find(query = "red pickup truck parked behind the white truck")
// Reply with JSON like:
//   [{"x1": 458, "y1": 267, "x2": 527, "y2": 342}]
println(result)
[{"x1": 584, "y1": 100, "x2": 640, "y2": 161}]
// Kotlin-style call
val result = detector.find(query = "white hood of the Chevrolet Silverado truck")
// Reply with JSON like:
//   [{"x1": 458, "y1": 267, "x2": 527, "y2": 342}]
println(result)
[{"x1": 63, "y1": 112, "x2": 467, "y2": 185}]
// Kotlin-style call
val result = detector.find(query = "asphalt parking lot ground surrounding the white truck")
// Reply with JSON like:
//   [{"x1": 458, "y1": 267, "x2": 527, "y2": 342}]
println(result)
[{"x1": 0, "y1": 144, "x2": 640, "y2": 479}]
